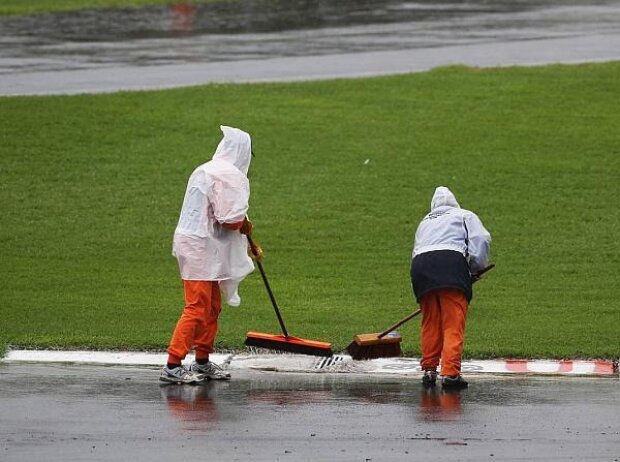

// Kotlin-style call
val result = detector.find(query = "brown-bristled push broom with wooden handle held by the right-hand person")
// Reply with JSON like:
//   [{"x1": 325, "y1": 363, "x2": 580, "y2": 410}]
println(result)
[{"x1": 346, "y1": 264, "x2": 495, "y2": 359}]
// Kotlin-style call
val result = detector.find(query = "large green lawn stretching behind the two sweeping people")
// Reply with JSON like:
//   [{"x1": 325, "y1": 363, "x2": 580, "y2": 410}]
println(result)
[{"x1": 0, "y1": 63, "x2": 620, "y2": 358}]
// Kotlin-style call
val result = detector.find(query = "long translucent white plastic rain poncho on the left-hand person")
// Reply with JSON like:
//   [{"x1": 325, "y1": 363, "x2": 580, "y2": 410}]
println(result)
[{"x1": 172, "y1": 125, "x2": 254, "y2": 306}]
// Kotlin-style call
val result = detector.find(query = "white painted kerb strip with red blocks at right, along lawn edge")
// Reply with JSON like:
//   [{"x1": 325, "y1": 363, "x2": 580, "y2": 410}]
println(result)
[{"x1": 2, "y1": 350, "x2": 618, "y2": 376}]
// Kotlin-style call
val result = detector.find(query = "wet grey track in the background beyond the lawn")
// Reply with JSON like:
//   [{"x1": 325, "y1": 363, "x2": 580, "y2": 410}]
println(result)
[{"x1": 0, "y1": 0, "x2": 620, "y2": 94}]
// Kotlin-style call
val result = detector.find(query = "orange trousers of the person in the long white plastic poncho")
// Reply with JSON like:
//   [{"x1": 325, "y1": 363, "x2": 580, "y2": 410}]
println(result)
[{"x1": 168, "y1": 280, "x2": 222, "y2": 364}]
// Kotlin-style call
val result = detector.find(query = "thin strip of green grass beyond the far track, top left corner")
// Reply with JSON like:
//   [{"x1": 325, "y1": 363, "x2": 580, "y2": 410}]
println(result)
[{"x1": 0, "y1": 0, "x2": 223, "y2": 16}]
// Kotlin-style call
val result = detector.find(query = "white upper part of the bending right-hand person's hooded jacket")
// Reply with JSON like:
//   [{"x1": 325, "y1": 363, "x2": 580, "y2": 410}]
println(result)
[{"x1": 413, "y1": 186, "x2": 491, "y2": 273}]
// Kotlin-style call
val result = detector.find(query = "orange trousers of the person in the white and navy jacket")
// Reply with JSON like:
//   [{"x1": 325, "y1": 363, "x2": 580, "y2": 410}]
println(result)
[{"x1": 420, "y1": 289, "x2": 468, "y2": 375}]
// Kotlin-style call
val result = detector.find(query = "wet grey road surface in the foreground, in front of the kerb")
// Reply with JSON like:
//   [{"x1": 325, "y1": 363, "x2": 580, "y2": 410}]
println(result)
[{"x1": 0, "y1": 364, "x2": 620, "y2": 462}]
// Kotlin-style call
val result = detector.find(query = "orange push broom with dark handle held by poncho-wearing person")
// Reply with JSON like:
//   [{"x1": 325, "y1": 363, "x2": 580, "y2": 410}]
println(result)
[{"x1": 245, "y1": 235, "x2": 334, "y2": 356}]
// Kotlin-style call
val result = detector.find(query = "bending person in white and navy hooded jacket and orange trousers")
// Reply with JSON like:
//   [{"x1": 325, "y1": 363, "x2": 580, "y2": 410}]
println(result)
[{"x1": 411, "y1": 186, "x2": 491, "y2": 388}]
